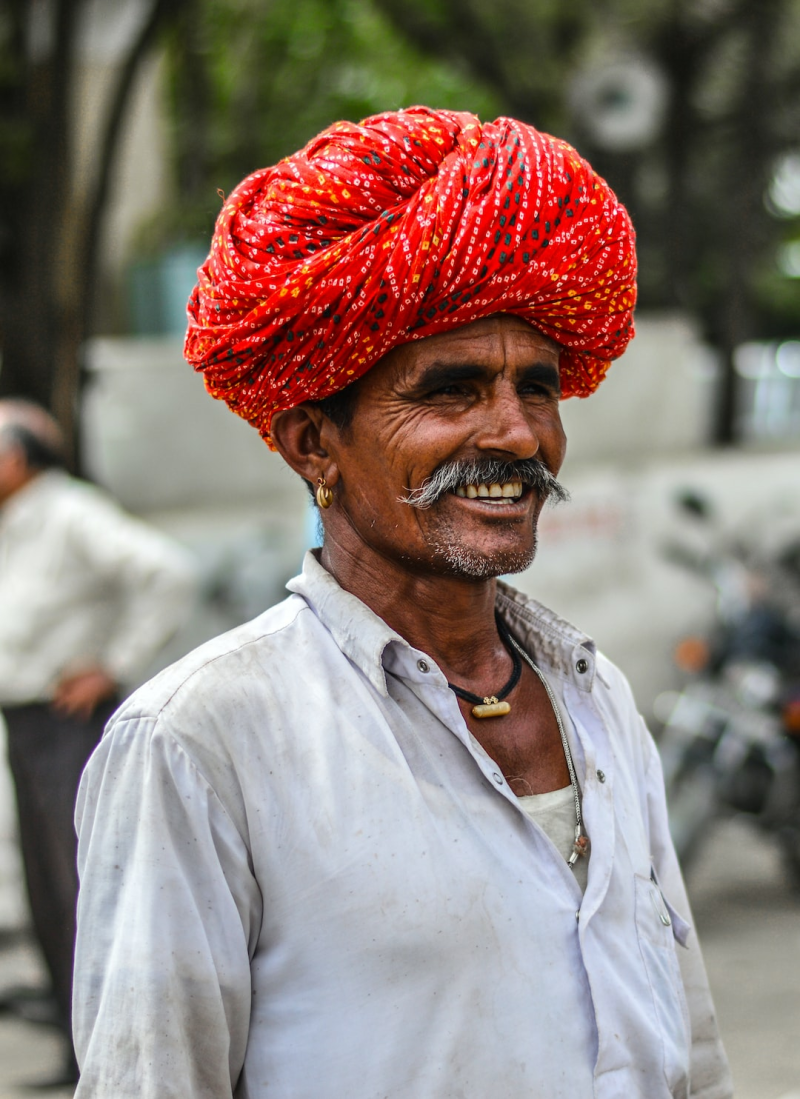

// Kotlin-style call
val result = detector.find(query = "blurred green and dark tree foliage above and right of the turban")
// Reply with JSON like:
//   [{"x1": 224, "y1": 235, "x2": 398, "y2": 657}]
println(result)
[{"x1": 158, "y1": 0, "x2": 800, "y2": 343}]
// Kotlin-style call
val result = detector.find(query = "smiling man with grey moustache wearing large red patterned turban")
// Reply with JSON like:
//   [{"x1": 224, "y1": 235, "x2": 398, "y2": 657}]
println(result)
[{"x1": 76, "y1": 108, "x2": 731, "y2": 1099}]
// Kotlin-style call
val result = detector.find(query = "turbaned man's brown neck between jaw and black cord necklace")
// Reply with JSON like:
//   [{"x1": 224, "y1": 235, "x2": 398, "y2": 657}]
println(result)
[{"x1": 321, "y1": 523, "x2": 508, "y2": 680}]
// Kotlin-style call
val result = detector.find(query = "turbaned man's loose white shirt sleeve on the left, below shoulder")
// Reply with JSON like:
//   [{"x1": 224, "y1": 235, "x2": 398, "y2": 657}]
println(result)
[{"x1": 74, "y1": 718, "x2": 260, "y2": 1099}]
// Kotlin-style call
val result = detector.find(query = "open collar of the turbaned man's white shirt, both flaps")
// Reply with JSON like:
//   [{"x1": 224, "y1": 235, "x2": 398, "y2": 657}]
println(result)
[{"x1": 287, "y1": 550, "x2": 596, "y2": 696}]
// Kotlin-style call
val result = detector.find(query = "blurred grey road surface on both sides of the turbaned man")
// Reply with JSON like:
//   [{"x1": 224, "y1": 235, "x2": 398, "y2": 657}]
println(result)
[{"x1": 0, "y1": 821, "x2": 800, "y2": 1099}]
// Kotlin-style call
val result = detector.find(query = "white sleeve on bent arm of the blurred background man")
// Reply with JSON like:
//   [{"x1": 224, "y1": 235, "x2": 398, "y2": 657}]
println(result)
[{"x1": 71, "y1": 495, "x2": 197, "y2": 684}]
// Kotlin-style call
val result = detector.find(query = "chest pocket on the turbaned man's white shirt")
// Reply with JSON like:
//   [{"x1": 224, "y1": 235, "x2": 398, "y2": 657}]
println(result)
[{"x1": 635, "y1": 874, "x2": 691, "y2": 1099}]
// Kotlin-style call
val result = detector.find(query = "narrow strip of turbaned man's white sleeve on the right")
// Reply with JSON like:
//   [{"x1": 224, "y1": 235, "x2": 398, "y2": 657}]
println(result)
[{"x1": 645, "y1": 731, "x2": 733, "y2": 1099}]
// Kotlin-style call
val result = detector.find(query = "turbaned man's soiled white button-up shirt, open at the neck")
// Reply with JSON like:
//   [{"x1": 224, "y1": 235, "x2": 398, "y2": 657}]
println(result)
[{"x1": 74, "y1": 555, "x2": 732, "y2": 1099}]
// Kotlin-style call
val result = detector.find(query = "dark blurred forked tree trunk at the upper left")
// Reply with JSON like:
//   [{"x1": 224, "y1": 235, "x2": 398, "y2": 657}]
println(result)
[{"x1": 0, "y1": 0, "x2": 187, "y2": 466}]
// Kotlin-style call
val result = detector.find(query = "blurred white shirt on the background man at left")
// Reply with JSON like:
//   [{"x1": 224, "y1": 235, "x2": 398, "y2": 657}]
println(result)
[{"x1": 0, "y1": 470, "x2": 195, "y2": 706}]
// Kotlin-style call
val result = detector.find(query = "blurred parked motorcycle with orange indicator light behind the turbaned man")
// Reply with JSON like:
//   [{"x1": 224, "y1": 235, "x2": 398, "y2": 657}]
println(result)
[{"x1": 655, "y1": 492, "x2": 800, "y2": 888}]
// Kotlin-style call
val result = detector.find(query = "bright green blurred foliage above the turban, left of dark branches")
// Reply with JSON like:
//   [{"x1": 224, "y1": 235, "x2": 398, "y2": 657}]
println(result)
[{"x1": 154, "y1": 0, "x2": 501, "y2": 245}]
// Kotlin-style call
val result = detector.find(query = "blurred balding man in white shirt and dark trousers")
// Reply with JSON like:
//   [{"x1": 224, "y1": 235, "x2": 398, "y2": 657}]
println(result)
[{"x1": 0, "y1": 400, "x2": 193, "y2": 1076}]
